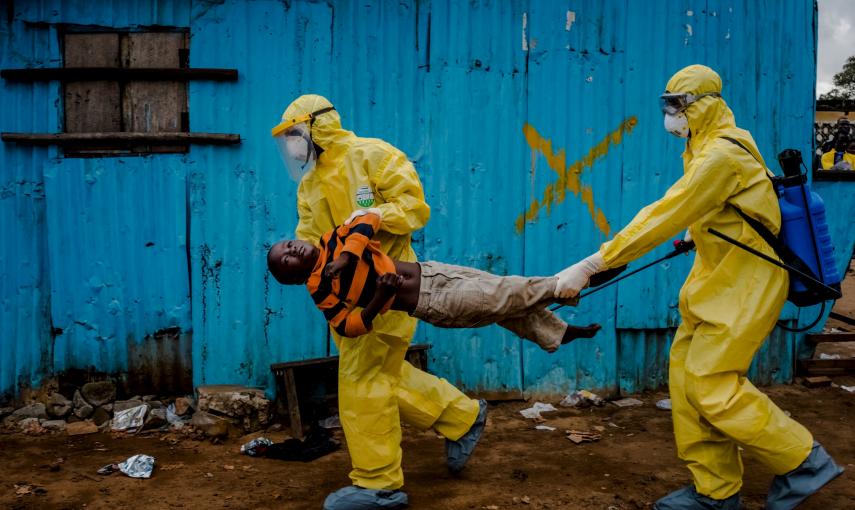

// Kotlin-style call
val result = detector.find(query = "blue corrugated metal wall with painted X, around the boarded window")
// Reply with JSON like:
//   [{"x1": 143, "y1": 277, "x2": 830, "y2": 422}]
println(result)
[{"x1": 0, "y1": 0, "x2": 855, "y2": 394}]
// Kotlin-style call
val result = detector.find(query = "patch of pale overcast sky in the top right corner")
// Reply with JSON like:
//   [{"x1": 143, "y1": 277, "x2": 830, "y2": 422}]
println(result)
[{"x1": 816, "y1": 0, "x2": 855, "y2": 96}]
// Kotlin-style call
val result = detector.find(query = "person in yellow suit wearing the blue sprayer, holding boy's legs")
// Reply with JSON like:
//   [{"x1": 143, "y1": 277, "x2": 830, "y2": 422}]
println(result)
[{"x1": 556, "y1": 65, "x2": 842, "y2": 510}]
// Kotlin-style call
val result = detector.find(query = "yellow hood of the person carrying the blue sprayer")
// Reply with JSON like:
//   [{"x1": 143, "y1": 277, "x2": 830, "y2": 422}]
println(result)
[{"x1": 665, "y1": 64, "x2": 736, "y2": 152}]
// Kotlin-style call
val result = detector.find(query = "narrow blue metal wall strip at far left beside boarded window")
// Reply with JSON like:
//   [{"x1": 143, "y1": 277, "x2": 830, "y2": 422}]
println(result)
[{"x1": 0, "y1": 19, "x2": 57, "y2": 396}]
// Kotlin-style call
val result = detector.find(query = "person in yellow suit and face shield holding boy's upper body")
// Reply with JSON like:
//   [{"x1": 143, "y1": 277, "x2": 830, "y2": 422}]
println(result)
[{"x1": 272, "y1": 95, "x2": 487, "y2": 510}]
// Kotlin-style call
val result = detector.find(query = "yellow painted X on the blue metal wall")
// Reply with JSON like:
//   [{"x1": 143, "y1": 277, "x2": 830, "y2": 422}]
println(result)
[{"x1": 514, "y1": 117, "x2": 638, "y2": 237}]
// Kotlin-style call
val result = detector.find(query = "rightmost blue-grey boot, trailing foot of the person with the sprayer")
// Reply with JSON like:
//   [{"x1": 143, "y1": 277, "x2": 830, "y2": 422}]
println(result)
[{"x1": 766, "y1": 441, "x2": 843, "y2": 510}]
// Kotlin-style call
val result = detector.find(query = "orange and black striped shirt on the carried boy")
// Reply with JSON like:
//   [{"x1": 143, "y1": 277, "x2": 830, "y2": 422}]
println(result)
[{"x1": 306, "y1": 214, "x2": 395, "y2": 337}]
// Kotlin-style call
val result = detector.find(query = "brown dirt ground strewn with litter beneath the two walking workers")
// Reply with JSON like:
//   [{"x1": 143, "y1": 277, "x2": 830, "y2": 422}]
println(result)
[{"x1": 0, "y1": 386, "x2": 855, "y2": 510}]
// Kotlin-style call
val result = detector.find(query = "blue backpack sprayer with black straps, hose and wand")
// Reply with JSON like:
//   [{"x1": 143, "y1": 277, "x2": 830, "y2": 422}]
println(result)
[{"x1": 552, "y1": 145, "x2": 842, "y2": 332}]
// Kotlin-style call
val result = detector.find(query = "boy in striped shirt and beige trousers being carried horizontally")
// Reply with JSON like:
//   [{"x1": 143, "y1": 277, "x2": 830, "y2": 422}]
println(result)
[{"x1": 267, "y1": 213, "x2": 600, "y2": 352}]
